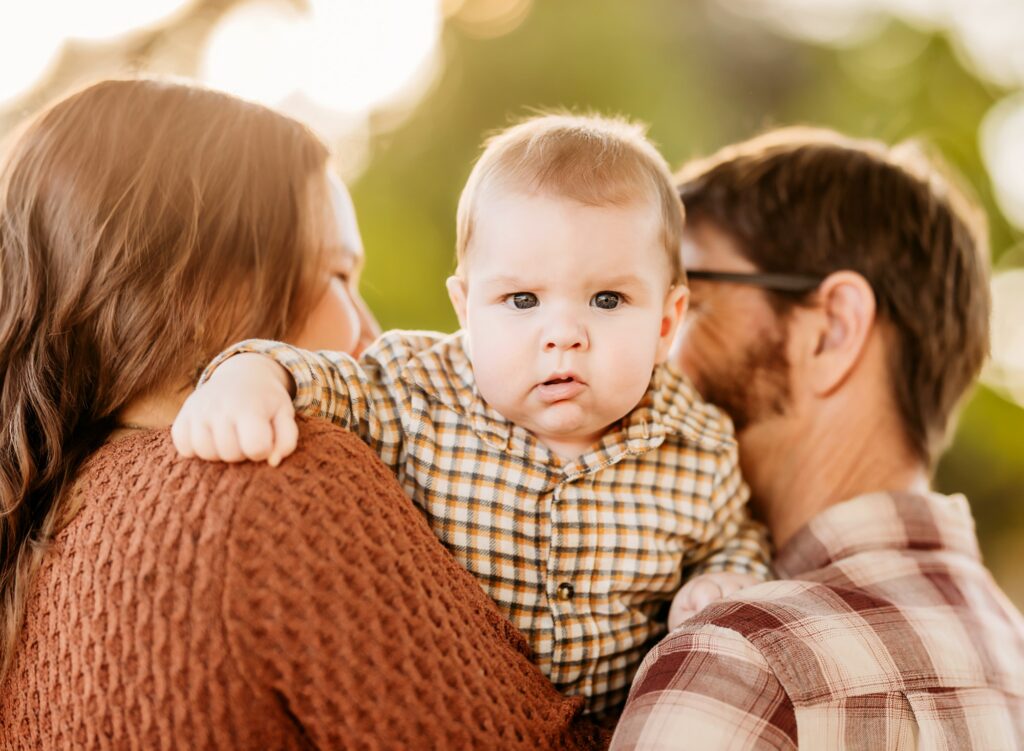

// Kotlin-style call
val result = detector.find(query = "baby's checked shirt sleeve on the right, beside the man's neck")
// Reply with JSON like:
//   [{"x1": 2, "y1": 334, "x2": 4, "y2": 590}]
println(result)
[{"x1": 686, "y1": 444, "x2": 774, "y2": 581}]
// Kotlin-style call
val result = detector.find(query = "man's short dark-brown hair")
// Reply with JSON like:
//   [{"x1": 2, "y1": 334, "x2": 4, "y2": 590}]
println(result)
[{"x1": 678, "y1": 127, "x2": 989, "y2": 465}]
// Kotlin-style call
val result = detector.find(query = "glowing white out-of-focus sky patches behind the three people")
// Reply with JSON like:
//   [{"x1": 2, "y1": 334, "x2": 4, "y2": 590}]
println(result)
[{"x1": 0, "y1": 0, "x2": 1024, "y2": 405}]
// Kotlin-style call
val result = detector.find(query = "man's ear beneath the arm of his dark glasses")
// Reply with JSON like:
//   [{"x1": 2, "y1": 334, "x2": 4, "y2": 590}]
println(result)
[{"x1": 808, "y1": 272, "x2": 876, "y2": 395}]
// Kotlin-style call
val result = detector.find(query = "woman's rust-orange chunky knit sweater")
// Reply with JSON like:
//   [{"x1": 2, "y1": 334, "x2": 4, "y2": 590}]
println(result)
[{"x1": 0, "y1": 422, "x2": 604, "y2": 749}]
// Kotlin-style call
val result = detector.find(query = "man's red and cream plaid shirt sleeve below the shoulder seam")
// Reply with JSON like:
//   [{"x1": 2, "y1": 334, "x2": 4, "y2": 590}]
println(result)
[{"x1": 611, "y1": 625, "x2": 797, "y2": 751}]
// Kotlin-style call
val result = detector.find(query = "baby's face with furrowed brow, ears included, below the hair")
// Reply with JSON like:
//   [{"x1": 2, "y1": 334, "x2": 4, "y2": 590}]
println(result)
[{"x1": 449, "y1": 191, "x2": 686, "y2": 459}]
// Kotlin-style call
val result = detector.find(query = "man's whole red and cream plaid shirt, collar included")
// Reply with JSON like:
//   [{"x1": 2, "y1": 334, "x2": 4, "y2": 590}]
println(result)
[{"x1": 611, "y1": 493, "x2": 1024, "y2": 751}]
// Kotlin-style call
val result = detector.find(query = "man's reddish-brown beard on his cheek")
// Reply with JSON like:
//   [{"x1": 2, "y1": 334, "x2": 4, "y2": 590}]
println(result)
[{"x1": 695, "y1": 330, "x2": 791, "y2": 432}]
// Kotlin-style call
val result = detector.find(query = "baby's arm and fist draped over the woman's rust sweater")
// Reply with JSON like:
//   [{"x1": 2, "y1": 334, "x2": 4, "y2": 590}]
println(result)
[{"x1": 172, "y1": 340, "x2": 401, "y2": 467}]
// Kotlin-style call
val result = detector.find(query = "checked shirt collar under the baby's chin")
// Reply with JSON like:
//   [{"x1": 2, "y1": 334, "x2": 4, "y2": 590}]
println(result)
[{"x1": 399, "y1": 331, "x2": 733, "y2": 470}]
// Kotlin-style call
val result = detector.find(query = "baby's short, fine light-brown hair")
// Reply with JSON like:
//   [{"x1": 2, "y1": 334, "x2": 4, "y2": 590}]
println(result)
[{"x1": 456, "y1": 114, "x2": 685, "y2": 283}]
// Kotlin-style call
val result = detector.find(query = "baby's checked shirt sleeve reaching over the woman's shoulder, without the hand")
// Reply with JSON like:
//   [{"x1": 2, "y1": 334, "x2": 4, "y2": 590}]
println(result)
[{"x1": 200, "y1": 339, "x2": 403, "y2": 470}]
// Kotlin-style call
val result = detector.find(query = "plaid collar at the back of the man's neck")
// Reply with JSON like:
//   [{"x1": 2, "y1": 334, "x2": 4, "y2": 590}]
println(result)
[{"x1": 774, "y1": 492, "x2": 981, "y2": 578}]
